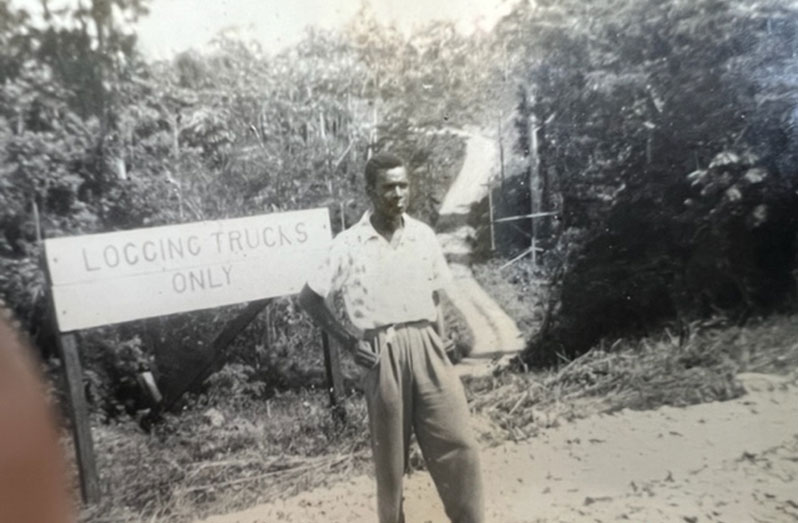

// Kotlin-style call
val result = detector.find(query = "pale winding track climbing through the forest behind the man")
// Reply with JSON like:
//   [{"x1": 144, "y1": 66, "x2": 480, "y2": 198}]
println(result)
[{"x1": 438, "y1": 131, "x2": 524, "y2": 360}]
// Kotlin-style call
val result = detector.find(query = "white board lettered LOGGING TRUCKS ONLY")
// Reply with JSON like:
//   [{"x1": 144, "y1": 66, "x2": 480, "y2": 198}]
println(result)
[{"x1": 45, "y1": 209, "x2": 332, "y2": 332}]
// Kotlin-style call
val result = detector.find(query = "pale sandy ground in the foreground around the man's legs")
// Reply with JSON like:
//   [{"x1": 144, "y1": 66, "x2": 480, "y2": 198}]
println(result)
[{"x1": 205, "y1": 374, "x2": 798, "y2": 523}]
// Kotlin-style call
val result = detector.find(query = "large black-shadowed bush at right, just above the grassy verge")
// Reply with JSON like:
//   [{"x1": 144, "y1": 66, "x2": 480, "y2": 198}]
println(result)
[{"x1": 525, "y1": 152, "x2": 798, "y2": 364}]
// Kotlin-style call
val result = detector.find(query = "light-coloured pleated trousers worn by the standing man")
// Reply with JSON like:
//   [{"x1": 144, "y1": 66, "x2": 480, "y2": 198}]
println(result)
[{"x1": 363, "y1": 322, "x2": 484, "y2": 523}]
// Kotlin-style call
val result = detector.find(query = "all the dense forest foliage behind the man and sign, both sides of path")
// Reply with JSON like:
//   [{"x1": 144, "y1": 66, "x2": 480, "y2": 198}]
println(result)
[{"x1": 0, "y1": 0, "x2": 798, "y2": 412}]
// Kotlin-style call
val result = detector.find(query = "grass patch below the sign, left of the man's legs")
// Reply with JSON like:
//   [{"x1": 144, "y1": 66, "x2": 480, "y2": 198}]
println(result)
[{"x1": 74, "y1": 391, "x2": 370, "y2": 521}]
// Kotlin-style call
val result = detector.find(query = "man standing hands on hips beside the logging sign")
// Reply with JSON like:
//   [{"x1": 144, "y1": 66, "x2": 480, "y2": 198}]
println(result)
[{"x1": 300, "y1": 153, "x2": 483, "y2": 523}]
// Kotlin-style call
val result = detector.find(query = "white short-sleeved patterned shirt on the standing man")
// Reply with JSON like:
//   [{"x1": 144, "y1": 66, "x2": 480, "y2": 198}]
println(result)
[{"x1": 307, "y1": 212, "x2": 452, "y2": 330}]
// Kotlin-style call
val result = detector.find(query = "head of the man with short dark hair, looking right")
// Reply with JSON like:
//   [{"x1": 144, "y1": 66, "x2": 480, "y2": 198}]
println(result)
[{"x1": 366, "y1": 153, "x2": 410, "y2": 218}]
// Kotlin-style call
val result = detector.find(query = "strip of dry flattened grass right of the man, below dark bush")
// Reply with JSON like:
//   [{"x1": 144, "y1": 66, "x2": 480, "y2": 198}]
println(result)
[{"x1": 467, "y1": 316, "x2": 798, "y2": 444}]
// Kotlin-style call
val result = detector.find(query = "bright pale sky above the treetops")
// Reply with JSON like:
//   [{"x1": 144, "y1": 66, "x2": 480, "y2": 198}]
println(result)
[{"x1": 12, "y1": 0, "x2": 518, "y2": 58}]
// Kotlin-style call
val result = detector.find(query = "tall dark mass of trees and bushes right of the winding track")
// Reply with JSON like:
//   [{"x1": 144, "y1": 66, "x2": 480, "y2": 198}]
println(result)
[{"x1": 504, "y1": 0, "x2": 798, "y2": 363}]
